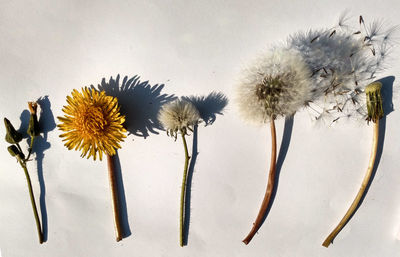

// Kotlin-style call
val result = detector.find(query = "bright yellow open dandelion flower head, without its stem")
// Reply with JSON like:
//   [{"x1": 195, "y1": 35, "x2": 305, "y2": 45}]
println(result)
[{"x1": 57, "y1": 87, "x2": 126, "y2": 160}]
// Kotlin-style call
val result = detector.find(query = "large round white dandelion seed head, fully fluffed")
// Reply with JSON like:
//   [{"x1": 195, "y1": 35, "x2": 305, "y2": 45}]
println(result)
[{"x1": 237, "y1": 48, "x2": 311, "y2": 123}]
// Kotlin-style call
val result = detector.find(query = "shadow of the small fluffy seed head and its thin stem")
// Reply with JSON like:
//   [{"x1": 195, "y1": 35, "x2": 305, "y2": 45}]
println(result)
[{"x1": 182, "y1": 92, "x2": 228, "y2": 245}]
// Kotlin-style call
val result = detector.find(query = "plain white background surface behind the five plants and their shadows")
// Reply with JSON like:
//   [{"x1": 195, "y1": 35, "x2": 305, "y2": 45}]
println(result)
[{"x1": 0, "y1": 0, "x2": 400, "y2": 257}]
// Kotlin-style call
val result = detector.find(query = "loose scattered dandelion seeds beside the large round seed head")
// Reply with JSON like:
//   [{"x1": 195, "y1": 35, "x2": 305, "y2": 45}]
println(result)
[{"x1": 288, "y1": 13, "x2": 397, "y2": 121}]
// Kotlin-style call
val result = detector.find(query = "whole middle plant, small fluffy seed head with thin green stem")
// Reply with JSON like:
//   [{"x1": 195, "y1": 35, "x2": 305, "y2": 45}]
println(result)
[{"x1": 158, "y1": 99, "x2": 200, "y2": 247}]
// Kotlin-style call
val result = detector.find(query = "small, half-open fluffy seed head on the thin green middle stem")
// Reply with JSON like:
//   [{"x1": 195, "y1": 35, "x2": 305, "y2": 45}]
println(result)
[{"x1": 158, "y1": 99, "x2": 200, "y2": 137}]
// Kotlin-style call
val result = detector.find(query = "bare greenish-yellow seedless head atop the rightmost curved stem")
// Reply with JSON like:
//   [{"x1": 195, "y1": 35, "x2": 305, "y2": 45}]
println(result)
[{"x1": 365, "y1": 82, "x2": 383, "y2": 122}]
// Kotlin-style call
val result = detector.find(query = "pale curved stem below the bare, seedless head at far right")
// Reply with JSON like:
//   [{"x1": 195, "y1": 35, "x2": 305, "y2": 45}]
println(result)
[{"x1": 322, "y1": 119, "x2": 379, "y2": 247}]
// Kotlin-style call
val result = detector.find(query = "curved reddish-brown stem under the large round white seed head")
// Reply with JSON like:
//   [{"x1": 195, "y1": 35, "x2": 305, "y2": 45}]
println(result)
[{"x1": 243, "y1": 117, "x2": 276, "y2": 245}]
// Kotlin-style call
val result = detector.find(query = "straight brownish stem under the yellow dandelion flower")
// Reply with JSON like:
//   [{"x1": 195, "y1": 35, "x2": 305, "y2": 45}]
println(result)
[{"x1": 107, "y1": 155, "x2": 122, "y2": 242}]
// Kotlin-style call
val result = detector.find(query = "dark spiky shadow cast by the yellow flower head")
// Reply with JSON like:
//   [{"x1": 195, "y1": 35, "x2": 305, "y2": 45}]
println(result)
[{"x1": 91, "y1": 74, "x2": 176, "y2": 138}]
